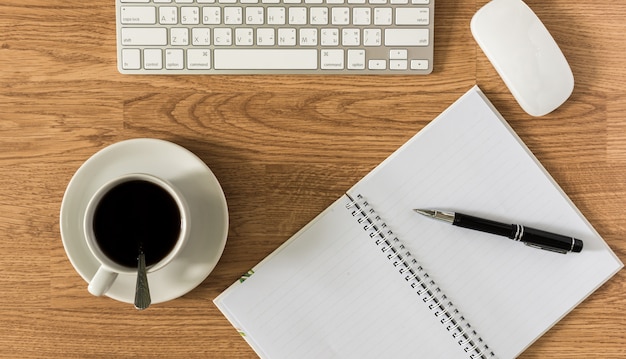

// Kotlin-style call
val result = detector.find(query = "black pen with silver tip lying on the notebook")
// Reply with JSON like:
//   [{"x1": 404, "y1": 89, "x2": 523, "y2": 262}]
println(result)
[{"x1": 414, "y1": 209, "x2": 583, "y2": 254}]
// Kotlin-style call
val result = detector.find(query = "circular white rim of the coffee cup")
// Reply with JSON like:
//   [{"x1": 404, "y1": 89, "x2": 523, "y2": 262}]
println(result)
[{"x1": 83, "y1": 172, "x2": 190, "y2": 273}]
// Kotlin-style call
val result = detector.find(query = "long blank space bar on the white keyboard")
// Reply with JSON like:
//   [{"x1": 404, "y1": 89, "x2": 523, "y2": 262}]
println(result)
[{"x1": 213, "y1": 49, "x2": 317, "y2": 70}]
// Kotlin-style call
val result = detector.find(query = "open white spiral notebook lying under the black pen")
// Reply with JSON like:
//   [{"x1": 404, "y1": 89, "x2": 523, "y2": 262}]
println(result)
[{"x1": 214, "y1": 87, "x2": 623, "y2": 359}]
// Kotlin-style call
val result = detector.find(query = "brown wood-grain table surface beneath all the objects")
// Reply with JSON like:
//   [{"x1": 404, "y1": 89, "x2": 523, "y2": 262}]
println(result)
[{"x1": 0, "y1": 0, "x2": 626, "y2": 359}]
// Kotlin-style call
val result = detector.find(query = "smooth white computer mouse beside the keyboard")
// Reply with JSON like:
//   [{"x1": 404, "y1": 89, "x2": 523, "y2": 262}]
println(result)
[{"x1": 470, "y1": 0, "x2": 574, "y2": 116}]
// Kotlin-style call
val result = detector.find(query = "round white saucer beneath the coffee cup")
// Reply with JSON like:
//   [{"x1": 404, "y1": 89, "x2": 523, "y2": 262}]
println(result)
[{"x1": 60, "y1": 138, "x2": 228, "y2": 304}]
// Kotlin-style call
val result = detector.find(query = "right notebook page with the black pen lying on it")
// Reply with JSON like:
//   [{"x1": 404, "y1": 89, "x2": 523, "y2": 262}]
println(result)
[{"x1": 349, "y1": 87, "x2": 622, "y2": 358}]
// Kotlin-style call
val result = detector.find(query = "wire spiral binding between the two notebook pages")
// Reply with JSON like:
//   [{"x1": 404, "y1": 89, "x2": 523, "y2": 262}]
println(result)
[{"x1": 346, "y1": 194, "x2": 496, "y2": 359}]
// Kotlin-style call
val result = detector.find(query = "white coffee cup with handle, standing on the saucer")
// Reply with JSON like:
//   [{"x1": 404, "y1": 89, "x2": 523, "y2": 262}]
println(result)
[{"x1": 83, "y1": 173, "x2": 190, "y2": 296}]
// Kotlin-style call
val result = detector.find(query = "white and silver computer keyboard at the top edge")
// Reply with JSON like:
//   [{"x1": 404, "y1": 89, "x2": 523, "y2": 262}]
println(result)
[{"x1": 116, "y1": 0, "x2": 435, "y2": 75}]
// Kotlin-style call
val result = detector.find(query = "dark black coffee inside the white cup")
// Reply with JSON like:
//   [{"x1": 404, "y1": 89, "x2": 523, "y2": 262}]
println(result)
[{"x1": 93, "y1": 180, "x2": 181, "y2": 268}]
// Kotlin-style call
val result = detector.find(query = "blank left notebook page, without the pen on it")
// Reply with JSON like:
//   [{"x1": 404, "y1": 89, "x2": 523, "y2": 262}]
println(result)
[{"x1": 215, "y1": 196, "x2": 467, "y2": 359}]
